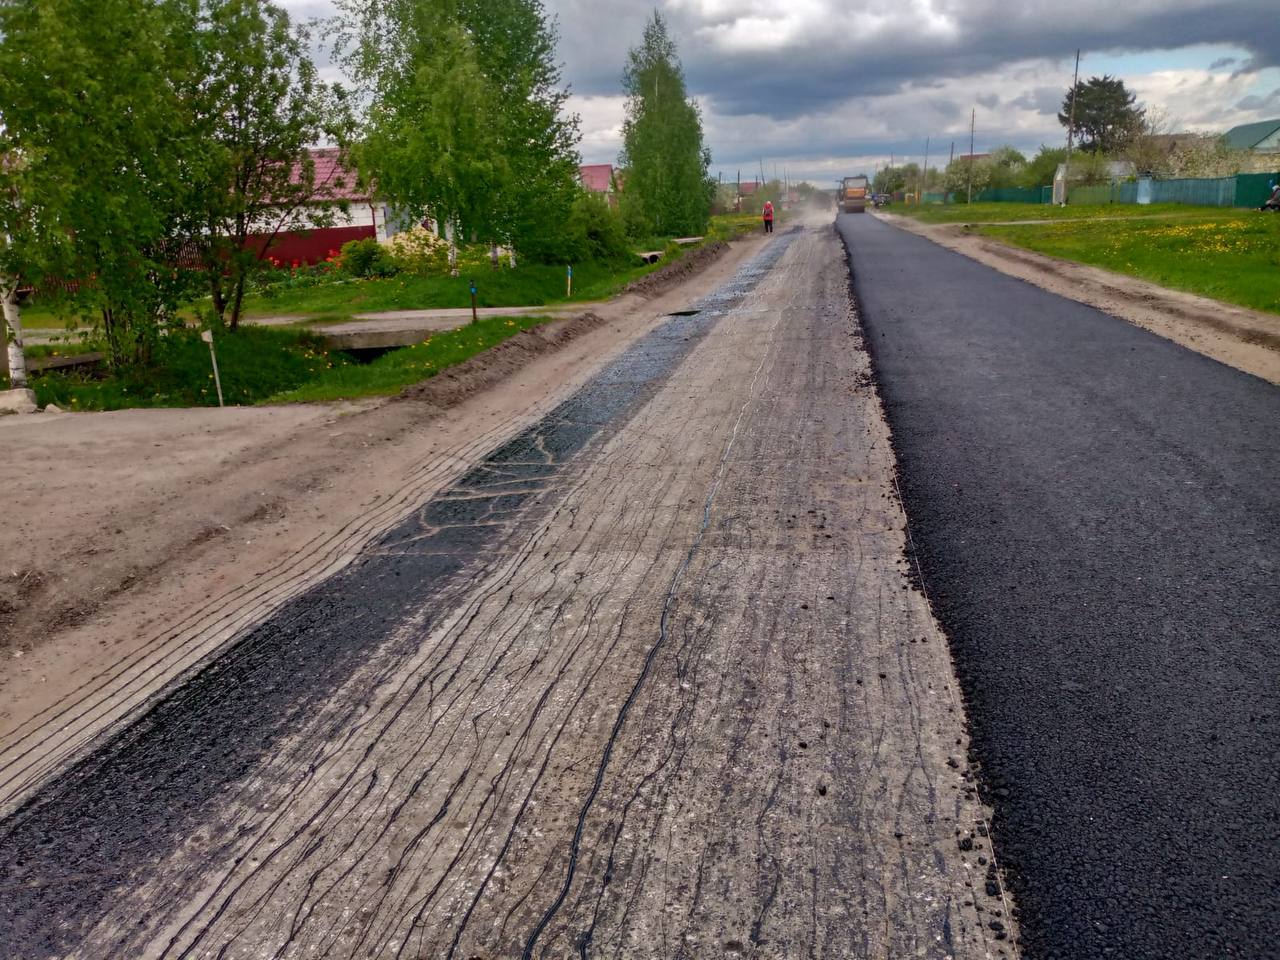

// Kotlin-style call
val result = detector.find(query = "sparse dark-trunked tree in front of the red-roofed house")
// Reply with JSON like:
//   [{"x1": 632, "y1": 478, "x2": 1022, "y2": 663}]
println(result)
[{"x1": 191, "y1": 0, "x2": 347, "y2": 330}]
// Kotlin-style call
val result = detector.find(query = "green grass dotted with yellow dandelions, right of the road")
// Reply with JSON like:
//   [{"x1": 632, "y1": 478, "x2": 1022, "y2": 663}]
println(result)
[{"x1": 978, "y1": 211, "x2": 1280, "y2": 314}]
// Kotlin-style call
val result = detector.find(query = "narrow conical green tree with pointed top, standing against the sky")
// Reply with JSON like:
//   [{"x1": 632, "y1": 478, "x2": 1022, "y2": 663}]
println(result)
[{"x1": 618, "y1": 10, "x2": 714, "y2": 236}]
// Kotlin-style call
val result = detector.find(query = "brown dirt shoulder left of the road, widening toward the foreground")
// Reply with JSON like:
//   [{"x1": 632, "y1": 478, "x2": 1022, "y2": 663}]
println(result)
[{"x1": 0, "y1": 237, "x2": 764, "y2": 808}]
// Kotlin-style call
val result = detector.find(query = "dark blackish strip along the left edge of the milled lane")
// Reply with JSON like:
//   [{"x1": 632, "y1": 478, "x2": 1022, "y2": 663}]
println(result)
[{"x1": 0, "y1": 232, "x2": 796, "y2": 960}]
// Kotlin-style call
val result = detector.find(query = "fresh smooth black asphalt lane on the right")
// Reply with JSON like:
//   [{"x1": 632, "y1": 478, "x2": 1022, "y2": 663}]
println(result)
[{"x1": 837, "y1": 215, "x2": 1280, "y2": 960}]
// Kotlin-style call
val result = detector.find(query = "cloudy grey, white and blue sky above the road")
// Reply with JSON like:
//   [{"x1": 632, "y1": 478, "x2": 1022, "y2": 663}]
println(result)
[{"x1": 284, "y1": 0, "x2": 1280, "y2": 186}]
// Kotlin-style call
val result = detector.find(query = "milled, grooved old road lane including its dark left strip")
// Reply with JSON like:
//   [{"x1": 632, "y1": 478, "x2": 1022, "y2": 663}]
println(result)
[{"x1": 0, "y1": 225, "x2": 1016, "y2": 960}]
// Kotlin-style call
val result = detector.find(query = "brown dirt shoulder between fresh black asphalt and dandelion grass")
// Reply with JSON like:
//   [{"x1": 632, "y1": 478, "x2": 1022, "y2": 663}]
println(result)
[{"x1": 876, "y1": 212, "x2": 1280, "y2": 384}]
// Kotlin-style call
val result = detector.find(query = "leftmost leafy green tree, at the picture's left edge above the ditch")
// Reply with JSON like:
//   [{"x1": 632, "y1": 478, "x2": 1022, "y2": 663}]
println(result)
[{"x1": 0, "y1": 0, "x2": 200, "y2": 365}]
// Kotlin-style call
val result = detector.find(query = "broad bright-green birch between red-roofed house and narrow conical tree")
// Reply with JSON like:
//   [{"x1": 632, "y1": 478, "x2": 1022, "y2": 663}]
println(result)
[{"x1": 339, "y1": 0, "x2": 577, "y2": 271}]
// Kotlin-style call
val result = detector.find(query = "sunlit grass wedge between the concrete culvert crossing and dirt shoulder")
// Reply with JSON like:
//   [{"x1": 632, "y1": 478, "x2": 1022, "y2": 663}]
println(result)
[{"x1": 268, "y1": 316, "x2": 549, "y2": 403}]
